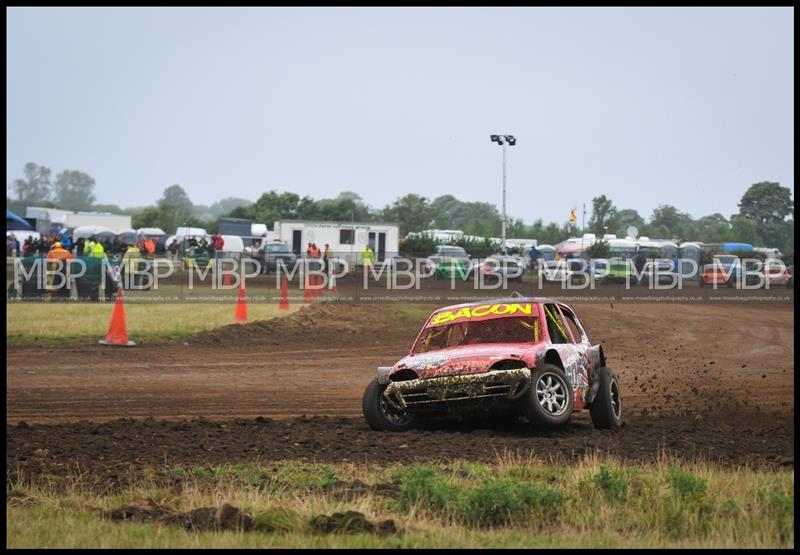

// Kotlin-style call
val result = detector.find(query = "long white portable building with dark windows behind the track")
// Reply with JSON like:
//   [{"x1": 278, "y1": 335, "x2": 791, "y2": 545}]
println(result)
[{"x1": 274, "y1": 220, "x2": 400, "y2": 265}]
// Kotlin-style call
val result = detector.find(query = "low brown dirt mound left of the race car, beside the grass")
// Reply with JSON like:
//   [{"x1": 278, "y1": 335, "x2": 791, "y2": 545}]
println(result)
[{"x1": 187, "y1": 303, "x2": 427, "y2": 346}]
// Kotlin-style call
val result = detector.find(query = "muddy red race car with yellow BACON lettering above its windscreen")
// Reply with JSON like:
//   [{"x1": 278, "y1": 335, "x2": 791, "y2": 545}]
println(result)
[{"x1": 362, "y1": 297, "x2": 622, "y2": 432}]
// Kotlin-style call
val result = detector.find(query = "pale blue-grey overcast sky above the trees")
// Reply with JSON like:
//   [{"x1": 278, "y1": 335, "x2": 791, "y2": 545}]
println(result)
[{"x1": 6, "y1": 8, "x2": 794, "y2": 222}]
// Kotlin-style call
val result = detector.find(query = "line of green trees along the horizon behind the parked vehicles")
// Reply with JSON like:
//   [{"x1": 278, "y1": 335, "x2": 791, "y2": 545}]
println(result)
[{"x1": 7, "y1": 162, "x2": 794, "y2": 254}]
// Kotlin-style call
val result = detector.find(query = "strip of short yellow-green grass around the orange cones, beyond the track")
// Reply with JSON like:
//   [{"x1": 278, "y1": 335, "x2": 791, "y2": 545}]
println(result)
[{"x1": 6, "y1": 303, "x2": 302, "y2": 344}]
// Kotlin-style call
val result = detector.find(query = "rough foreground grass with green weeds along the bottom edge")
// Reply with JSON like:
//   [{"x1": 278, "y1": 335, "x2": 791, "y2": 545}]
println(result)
[{"x1": 6, "y1": 455, "x2": 794, "y2": 547}]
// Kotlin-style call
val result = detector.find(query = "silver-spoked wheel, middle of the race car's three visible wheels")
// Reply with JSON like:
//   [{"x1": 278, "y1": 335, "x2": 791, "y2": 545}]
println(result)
[{"x1": 522, "y1": 364, "x2": 575, "y2": 429}]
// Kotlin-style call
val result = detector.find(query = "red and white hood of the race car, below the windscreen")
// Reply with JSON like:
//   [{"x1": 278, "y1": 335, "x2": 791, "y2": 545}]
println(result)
[{"x1": 390, "y1": 343, "x2": 541, "y2": 379}]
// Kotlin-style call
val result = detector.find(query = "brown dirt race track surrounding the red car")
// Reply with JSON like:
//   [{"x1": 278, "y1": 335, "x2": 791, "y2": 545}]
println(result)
[{"x1": 6, "y1": 303, "x2": 794, "y2": 475}]
